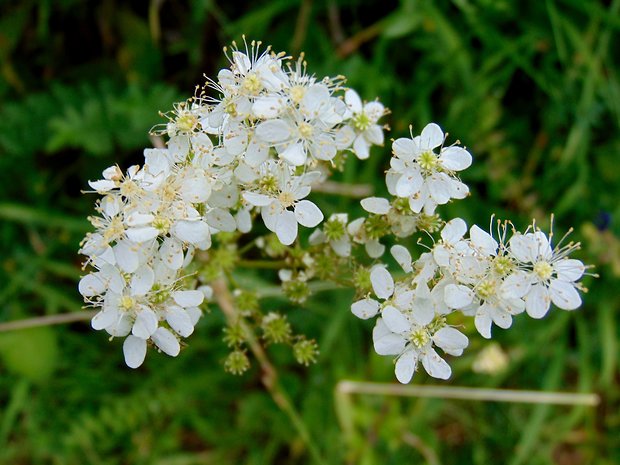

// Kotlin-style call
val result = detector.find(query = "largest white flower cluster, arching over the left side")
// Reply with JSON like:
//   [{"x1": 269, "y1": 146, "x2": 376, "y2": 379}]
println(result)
[{"x1": 79, "y1": 42, "x2": 385, "y2": 368}]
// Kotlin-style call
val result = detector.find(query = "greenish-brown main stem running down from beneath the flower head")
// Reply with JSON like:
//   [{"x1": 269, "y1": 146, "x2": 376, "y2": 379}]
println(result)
[{"x1": 211, "y1": 278, "x2": 325, "y2": 464}]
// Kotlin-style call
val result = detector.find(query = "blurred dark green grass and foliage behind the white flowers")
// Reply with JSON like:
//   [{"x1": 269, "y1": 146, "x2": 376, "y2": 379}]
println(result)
[{"x1": 0, "y1": 0, "x2": 620, "y2": 465}]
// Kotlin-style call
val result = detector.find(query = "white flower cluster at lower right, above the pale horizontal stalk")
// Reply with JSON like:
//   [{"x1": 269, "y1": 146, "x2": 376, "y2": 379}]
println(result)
[{"x1": 351, "y1": 218, "x2": 586, "y2": 383}]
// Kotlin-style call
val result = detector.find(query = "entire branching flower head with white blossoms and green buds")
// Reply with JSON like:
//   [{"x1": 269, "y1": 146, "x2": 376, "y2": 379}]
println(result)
[{"x1": 79, "y1": 42, "x2": 586, "y2": 383}]
